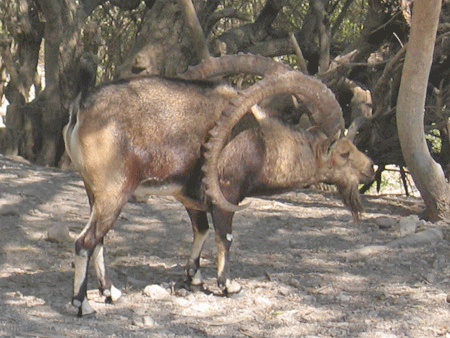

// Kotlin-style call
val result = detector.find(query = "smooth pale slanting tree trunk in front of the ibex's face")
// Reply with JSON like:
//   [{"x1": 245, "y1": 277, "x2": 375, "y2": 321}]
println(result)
[{"x1": 397, "y1": 0, "x2": 450, "y2": 221}]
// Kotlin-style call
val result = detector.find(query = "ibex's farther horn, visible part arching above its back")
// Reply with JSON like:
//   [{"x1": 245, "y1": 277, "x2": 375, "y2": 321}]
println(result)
[{"x1": 178, "y1": 54, "x2": 291, "y2": 80}]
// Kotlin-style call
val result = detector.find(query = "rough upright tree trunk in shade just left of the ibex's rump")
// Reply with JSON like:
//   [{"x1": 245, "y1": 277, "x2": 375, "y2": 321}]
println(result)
[{"x1": 23, "y1": 0, "x2": 93, "y2": 166}]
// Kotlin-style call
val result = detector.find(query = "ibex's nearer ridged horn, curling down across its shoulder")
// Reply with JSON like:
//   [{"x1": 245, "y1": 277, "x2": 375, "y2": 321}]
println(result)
[{"x1": 203, "y1": 70, "x2": 344, "y2": 212}]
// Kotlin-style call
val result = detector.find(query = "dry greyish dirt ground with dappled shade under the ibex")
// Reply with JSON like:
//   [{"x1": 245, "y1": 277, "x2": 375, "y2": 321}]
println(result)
[{"x1": 0, "y1": 156, "x2": 450, "y2": 338}]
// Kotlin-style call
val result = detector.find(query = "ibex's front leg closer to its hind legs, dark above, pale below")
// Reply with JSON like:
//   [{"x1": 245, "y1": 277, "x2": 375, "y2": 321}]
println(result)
[{"x1": 186, "y1": 208, "x2": 209, "y2": 291}]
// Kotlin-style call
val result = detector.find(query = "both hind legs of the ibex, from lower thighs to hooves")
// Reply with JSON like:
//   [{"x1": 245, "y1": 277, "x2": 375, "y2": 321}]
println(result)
[{"x1": 72, "y1": 191, "x2": 129, "y2": 317}]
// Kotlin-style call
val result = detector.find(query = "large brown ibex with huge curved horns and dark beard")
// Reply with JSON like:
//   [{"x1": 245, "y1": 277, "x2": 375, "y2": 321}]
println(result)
[{"x1": 63, "y1": 55, "x2": 372, "y2": 316}]
